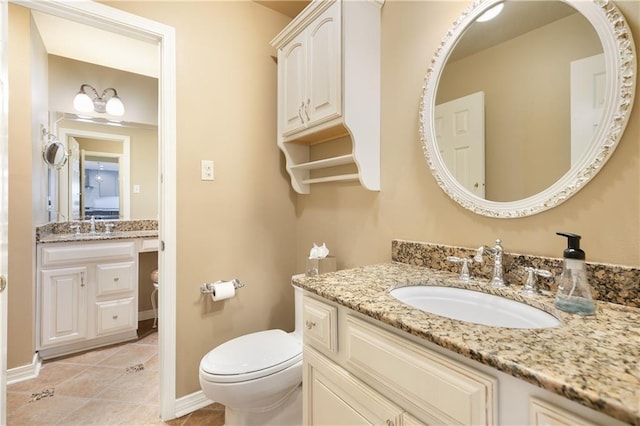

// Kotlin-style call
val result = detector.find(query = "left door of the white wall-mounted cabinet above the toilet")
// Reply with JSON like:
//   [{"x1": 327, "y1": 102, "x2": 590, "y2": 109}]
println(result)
[{"x1": 278, "y1": 32, "x2": 306, "y2": 136}]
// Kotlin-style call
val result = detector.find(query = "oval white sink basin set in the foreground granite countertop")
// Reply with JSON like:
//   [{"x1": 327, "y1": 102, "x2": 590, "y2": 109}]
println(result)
[{"x1": 390, "y1": 286, "x2": 560, "y2": 328}]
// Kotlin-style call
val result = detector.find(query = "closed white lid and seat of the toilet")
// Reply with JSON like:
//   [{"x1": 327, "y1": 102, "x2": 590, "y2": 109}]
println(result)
[{"x1": 200, "y1": 330, "x2": 302, "y2": 382}]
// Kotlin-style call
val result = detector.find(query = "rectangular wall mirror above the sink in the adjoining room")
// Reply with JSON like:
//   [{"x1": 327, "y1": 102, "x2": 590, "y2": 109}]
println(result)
[{"x1": 49, "y1": 114, "x2": 158, "y2": 221}]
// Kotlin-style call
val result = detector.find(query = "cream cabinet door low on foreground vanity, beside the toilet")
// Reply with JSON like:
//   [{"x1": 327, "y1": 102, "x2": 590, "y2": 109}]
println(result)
[{"x1": 302, "y1": 346, "x2": 403, "y2": 426}]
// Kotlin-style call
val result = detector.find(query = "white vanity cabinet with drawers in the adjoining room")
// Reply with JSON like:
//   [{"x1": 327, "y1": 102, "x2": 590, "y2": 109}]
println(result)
[{"x1": 35, "y1": 223, "x2": 158, "y2": 359}]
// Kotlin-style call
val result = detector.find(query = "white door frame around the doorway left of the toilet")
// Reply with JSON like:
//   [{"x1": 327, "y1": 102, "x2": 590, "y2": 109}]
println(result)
[{"x1": 10, "y1": 0, "x2": 177, "y2": 420}]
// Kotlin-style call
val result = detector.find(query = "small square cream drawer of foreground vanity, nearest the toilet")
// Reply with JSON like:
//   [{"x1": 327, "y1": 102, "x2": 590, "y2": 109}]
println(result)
[{"x1": 302, "y1": 296, "x2": 338, "y2": 352}]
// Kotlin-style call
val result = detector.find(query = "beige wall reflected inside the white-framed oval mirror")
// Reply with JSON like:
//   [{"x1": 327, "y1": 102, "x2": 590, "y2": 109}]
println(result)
[{"x1": 436, "y1": 13, "x2": 602, "y2": 201}]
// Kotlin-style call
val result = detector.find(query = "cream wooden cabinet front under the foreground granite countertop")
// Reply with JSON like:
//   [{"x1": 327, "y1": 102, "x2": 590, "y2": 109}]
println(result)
[{"x1": 302, "y1": 292, "x2": 624, "y2": 426}]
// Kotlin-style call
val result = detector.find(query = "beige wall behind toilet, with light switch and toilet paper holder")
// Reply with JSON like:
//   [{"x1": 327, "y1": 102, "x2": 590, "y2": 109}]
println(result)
[{"x1": 102, "y1": 1, "x2": 296, "y2": 397}]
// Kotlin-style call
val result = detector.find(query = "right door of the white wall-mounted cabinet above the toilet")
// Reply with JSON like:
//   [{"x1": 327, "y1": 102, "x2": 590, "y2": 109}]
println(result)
[{"x1": 304, "y1": 2, "x2": 342, "y2": 127}]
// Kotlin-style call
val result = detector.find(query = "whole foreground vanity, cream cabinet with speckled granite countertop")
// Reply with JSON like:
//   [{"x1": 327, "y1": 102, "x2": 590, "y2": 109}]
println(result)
[{"x1": 294, "y1": 263, "x2": 640, "y2": 425}]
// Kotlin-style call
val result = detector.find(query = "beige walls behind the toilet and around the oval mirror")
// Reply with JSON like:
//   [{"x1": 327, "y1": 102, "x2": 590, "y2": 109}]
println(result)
[{"x1": 9, "y1": 0, "x2": 640, "y2": 397}]
